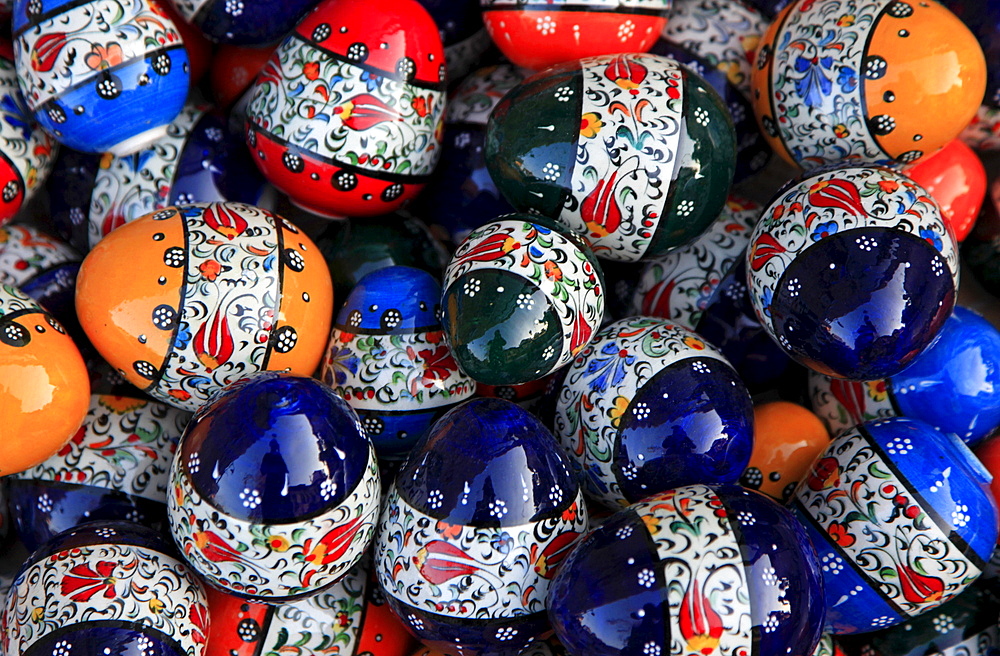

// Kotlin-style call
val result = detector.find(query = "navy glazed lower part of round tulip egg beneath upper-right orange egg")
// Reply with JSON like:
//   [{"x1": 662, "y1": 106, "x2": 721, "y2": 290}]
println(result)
[{"x1": 771, "y1": 228, "x2": 956, "y2": 380}]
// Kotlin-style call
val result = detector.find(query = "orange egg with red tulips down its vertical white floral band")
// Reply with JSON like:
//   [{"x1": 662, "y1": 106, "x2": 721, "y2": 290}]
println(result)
[{"x1": 77, "y1": 203, "x2": 333, "y2": 410}]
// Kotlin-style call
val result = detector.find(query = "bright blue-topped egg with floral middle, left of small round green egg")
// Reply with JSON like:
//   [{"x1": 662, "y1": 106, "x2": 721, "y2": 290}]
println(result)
[{"x1": 321, "y1": 266, "x2": 476, "y2": 460}]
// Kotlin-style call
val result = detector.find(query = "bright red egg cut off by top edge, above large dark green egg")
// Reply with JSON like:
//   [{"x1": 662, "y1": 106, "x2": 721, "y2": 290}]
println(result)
[{"x1": 480, "y1": 0, "x2": 671, "y2": 70}]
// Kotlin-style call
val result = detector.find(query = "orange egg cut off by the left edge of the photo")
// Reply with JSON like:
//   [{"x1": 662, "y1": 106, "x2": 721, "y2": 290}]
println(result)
[{"x1": 0, "y1": 285, "x2": 90, "y2": 476}]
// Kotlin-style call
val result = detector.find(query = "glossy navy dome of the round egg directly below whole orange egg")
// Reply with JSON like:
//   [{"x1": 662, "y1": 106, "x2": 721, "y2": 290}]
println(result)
[{"x1": 178, "y1": 372, "x2": 370, "y2": 524}]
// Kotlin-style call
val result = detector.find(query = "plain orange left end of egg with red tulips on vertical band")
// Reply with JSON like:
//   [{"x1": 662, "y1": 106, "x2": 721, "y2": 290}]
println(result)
[{"x1": 76, "y1": 214, "x2": 184, "y2": 389}]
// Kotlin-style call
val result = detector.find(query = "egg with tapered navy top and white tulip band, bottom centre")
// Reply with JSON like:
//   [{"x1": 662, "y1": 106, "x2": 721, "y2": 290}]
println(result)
[{"x1": 375, "y1": 399, "x2": 587, "y2": 656}]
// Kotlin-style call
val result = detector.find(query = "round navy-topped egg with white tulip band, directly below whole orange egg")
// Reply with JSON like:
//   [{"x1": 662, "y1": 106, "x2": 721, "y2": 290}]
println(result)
[{"x1": 168, "y1": 372, "x2": 380, "y2": 603}]
